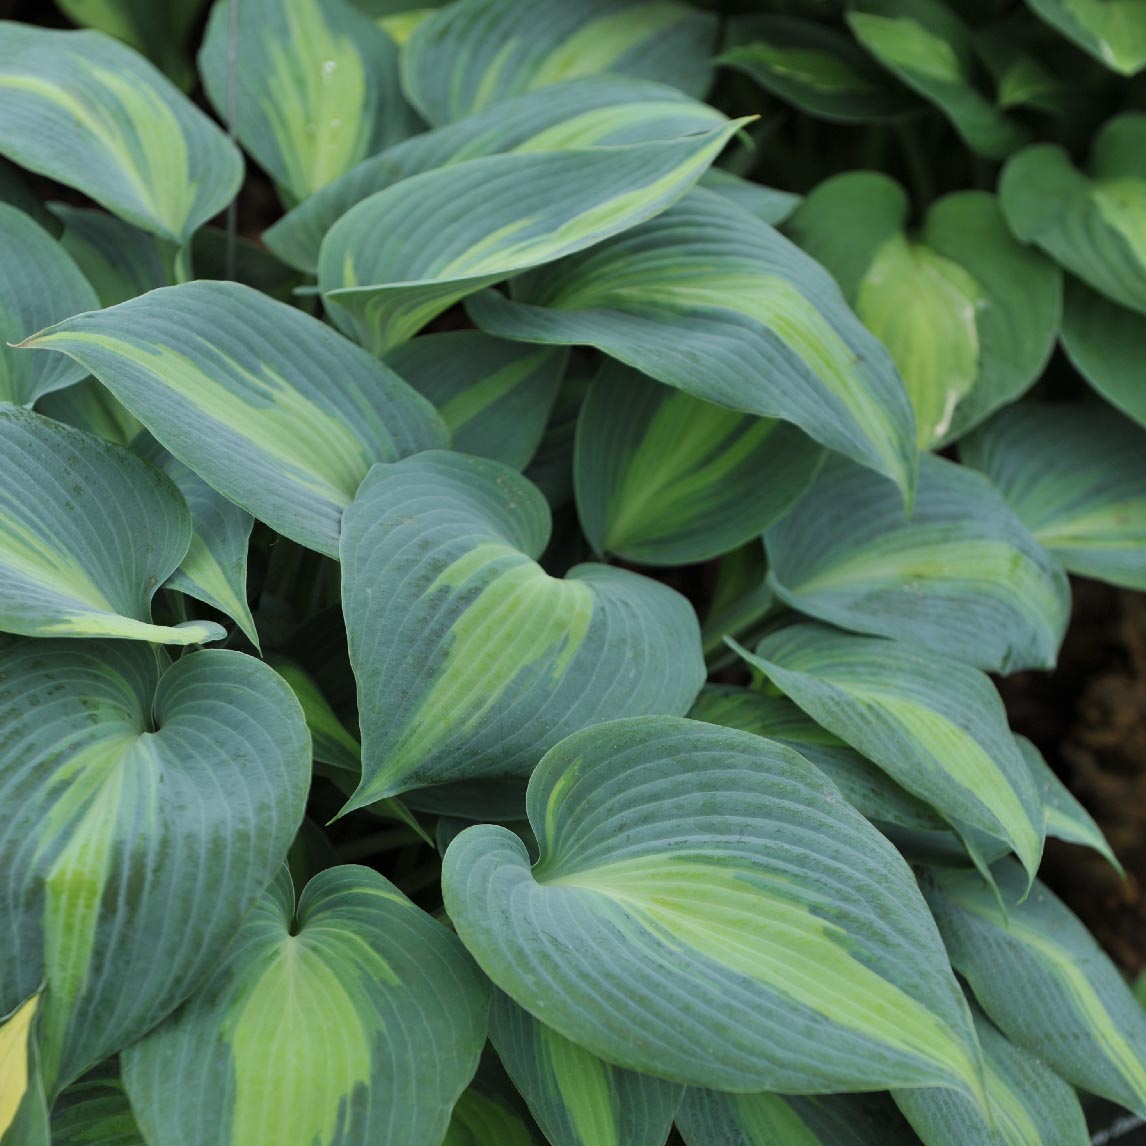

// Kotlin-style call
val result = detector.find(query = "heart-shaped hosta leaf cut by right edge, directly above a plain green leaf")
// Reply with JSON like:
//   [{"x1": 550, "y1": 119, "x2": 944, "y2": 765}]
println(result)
[{"x1": 999, "y1": 113, "x2": 1146, "y2": 312}]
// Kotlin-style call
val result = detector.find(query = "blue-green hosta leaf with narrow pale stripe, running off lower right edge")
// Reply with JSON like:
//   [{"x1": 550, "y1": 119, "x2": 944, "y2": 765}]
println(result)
[{"x1": 924, "y1": 862, "x2": 1146, "y2": 1114}]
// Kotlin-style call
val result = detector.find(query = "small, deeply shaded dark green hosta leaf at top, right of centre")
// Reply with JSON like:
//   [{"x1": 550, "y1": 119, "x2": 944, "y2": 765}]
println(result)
[{"x1": 717, "y1": 16, "x2": 919, "y2": 124}]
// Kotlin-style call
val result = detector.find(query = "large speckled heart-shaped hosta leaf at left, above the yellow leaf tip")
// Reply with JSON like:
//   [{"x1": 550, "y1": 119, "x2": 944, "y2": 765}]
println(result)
[{"x1": 0, "y1": 641, "x2": 311, "y2": 1093}]
